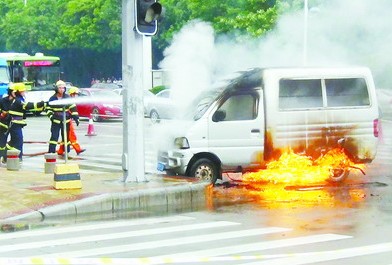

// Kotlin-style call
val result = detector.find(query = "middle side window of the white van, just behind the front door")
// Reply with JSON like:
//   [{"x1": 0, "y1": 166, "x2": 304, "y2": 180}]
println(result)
[{"x1": 279, "y1": 79, "x2": 323, "y2": 110}]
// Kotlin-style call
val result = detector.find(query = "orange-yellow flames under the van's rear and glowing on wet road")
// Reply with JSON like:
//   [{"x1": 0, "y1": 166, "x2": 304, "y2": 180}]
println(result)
[{"x1": 214, "y1": 148, "x2": 366, "y2": 209}]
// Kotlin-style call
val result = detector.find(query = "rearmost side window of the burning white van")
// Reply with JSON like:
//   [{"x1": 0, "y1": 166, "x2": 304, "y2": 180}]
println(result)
[{"x1": 325, "y1": 78, "x2": 370, "y2": 107}]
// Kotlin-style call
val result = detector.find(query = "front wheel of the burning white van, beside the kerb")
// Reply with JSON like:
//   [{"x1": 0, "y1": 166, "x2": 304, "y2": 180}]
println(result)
[{"x1": 190, "y1": 158, "x2": 219, "y2": 184}]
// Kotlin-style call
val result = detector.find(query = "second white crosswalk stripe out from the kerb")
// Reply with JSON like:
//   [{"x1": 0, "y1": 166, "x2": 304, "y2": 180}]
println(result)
[{"x1": 0, "y1": 221, "x2": 239, "y2": 253}]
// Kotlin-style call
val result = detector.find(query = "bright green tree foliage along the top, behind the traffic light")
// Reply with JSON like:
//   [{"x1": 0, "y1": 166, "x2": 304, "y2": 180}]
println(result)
[{"x1": 0, "y1": 0, "x2": 284, "y2": 55}]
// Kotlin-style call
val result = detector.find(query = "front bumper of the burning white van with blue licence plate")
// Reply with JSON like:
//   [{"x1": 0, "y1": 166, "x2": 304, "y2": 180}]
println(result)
[{"x1": 157, "y1": 150, "x2": 193, "y2": 175}]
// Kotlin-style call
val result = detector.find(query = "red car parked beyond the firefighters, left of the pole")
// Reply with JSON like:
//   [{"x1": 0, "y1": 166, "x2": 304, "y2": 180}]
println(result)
[{"x1": 76, "y1": 88, "x2": 122, "y2": 121}]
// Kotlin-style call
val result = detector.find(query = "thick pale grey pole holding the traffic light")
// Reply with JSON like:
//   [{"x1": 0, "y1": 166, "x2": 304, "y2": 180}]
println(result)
[{"x1": 122, "y1": 0, "x2": 147, "y2": 182}]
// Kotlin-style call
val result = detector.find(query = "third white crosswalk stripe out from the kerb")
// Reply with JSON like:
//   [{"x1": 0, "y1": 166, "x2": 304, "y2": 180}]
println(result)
[{"x1": 41, "y1": 227, "x2": 291, "y2": 257}]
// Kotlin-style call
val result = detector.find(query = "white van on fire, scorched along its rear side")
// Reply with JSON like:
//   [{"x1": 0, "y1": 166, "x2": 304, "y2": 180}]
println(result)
[{"x1": 158, "y1": 67, "x2": 379, "y2": 183}]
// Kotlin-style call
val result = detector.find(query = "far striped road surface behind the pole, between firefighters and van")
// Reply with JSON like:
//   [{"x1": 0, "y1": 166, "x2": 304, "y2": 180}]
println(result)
[{"x1": 22, "y1": 116, "x2": 156, "y2": 173}]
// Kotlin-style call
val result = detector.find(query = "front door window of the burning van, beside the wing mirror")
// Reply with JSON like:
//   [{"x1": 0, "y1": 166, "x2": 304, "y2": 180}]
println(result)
[{"x1": 216, "y1": 94, "x2": 257, "y2": 121}]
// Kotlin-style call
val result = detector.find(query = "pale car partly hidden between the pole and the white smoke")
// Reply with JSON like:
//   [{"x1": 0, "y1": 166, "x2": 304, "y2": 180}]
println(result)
[{"x1": 145, "y1": 89, "x2": 174, "y2": 123}]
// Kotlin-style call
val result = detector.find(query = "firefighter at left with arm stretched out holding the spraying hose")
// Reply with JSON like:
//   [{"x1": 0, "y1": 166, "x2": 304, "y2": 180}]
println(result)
[{"x1": 7, "y1": 83, "x2": 46, "y2": 160}]
